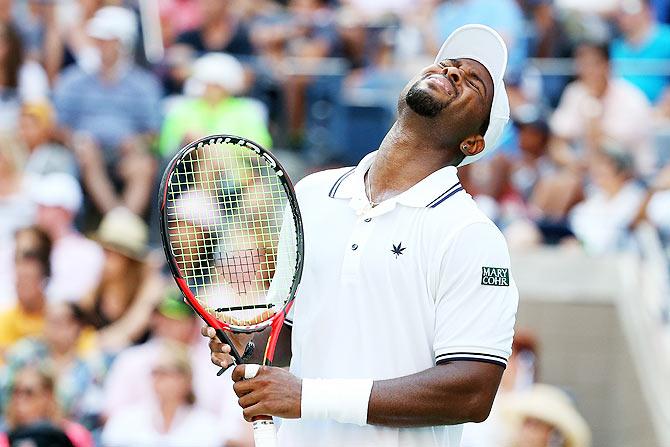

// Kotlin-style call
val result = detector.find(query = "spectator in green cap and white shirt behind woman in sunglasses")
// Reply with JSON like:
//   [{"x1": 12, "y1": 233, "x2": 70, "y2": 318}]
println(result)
[{"x1": 105, "y1": 287, "x2": 248, "y2": 442}]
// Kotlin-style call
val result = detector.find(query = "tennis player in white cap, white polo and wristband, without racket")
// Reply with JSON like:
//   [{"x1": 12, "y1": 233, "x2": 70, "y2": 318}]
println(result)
[{"x1": 202, "y1": 25, "x2": 518, "y2": 447}]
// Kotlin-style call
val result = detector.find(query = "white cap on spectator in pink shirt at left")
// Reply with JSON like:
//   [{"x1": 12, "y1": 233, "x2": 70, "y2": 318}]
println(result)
[{"x1": 31, "y1": 173, "x2": 83, "y2": 213}]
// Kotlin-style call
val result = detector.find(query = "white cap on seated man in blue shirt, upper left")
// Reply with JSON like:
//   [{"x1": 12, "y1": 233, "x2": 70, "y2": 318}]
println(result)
[{"x1": 86, "y1": 6, "x2": 137, "y2": 49}]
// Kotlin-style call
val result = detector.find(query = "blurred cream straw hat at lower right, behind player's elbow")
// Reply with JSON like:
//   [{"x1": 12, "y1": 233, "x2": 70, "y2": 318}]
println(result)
[{"x1": 501, "y1": 384, "x2": 591, "y2": 447}]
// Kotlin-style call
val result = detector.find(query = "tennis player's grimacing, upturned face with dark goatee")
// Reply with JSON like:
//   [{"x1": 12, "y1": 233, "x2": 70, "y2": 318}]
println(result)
[{"x1": 403, "y1": 59, "x2": 493, "y2": 136}]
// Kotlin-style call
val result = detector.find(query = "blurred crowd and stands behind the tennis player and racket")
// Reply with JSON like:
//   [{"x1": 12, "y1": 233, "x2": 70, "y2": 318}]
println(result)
[{"x1": 0, "y1": 0, "x2": 670, "y2": 447}]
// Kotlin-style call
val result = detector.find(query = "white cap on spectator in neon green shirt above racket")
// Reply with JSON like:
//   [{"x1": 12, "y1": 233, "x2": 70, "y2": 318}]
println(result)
[{"x1": 190, "y1": 53, "x2": 244, "y2": 95}]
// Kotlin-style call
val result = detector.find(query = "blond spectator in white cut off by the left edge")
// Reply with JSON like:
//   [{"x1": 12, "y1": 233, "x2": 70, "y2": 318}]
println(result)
[{"x1": 0, "y1": 134, "x2": 35, "y2": 247}]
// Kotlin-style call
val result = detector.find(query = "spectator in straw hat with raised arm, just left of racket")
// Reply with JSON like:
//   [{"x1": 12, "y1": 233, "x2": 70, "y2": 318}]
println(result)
[{"x1": 79, "y1": 208, "x2": 164, "y2": 354}]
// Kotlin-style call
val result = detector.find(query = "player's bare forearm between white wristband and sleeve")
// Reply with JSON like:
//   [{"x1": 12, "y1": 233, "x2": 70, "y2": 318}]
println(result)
[{"x1": 368, "y1": 362, "x2": 503, "y2": 427}]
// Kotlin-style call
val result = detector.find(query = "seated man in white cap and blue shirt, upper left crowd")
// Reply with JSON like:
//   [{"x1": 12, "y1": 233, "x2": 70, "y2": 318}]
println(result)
[{"x1": 55, "y1": 6, "x2": 160, "y2": 214}]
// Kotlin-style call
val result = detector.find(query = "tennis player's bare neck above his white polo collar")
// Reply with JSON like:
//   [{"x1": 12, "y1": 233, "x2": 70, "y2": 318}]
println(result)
[{"x1": 368, "y1": 120, "x2": 456, "y2": 202}]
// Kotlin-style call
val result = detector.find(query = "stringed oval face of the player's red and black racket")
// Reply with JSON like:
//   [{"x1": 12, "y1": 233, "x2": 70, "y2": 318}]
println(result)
[{"x1": 167, "y1": 140, "x2": 297, "y2": 326}]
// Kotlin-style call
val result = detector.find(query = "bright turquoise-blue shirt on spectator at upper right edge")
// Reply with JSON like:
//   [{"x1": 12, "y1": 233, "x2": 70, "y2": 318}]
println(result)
[{"x1": 611, "y1": 25, "x2": 670, "y2": 103}]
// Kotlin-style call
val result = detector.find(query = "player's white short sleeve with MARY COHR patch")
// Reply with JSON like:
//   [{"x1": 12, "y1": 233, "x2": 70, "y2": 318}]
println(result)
[{"x1": 433, "y1": 222, "x2": 519, "y2": 367}]
